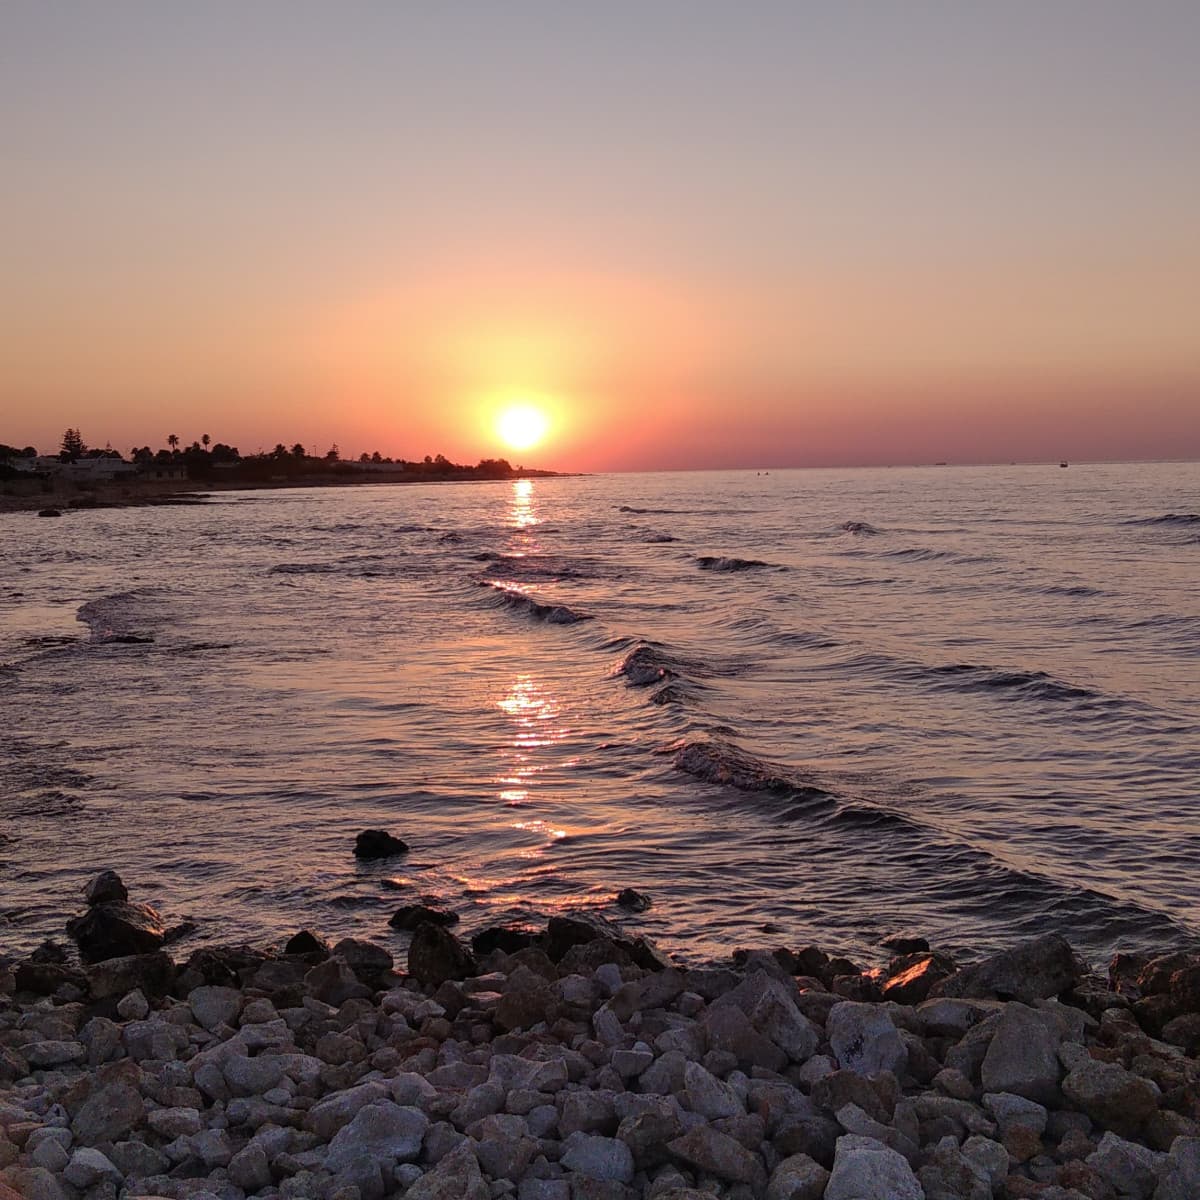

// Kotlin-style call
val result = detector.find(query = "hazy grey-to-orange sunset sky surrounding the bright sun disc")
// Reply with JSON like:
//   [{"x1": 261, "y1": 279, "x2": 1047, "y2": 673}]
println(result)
[{"x1": 0, "y1": 0, "x2": 1200, "y2": 470}]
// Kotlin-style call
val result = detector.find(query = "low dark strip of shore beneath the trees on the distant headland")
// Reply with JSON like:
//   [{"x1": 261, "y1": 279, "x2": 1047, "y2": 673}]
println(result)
[{"x1": 0, "y1": 470, "x2": 578, "y2": 514}]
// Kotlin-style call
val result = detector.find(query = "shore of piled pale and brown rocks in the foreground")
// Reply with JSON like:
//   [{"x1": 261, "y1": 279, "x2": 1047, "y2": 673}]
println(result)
[{"x1": 0, "y1": 872, "x2": 1200, "y2": 1200}]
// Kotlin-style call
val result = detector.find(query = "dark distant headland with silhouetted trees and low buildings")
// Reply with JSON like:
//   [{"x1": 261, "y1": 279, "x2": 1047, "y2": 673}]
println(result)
[{"x1": 0, "y1": 430, "x2": 562, "y2": 514}]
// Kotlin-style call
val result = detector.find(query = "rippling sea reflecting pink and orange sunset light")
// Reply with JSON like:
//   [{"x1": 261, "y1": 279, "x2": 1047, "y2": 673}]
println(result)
[{"x1": 0, "y1": 464, "x2": 1200, "y2": 961}]
